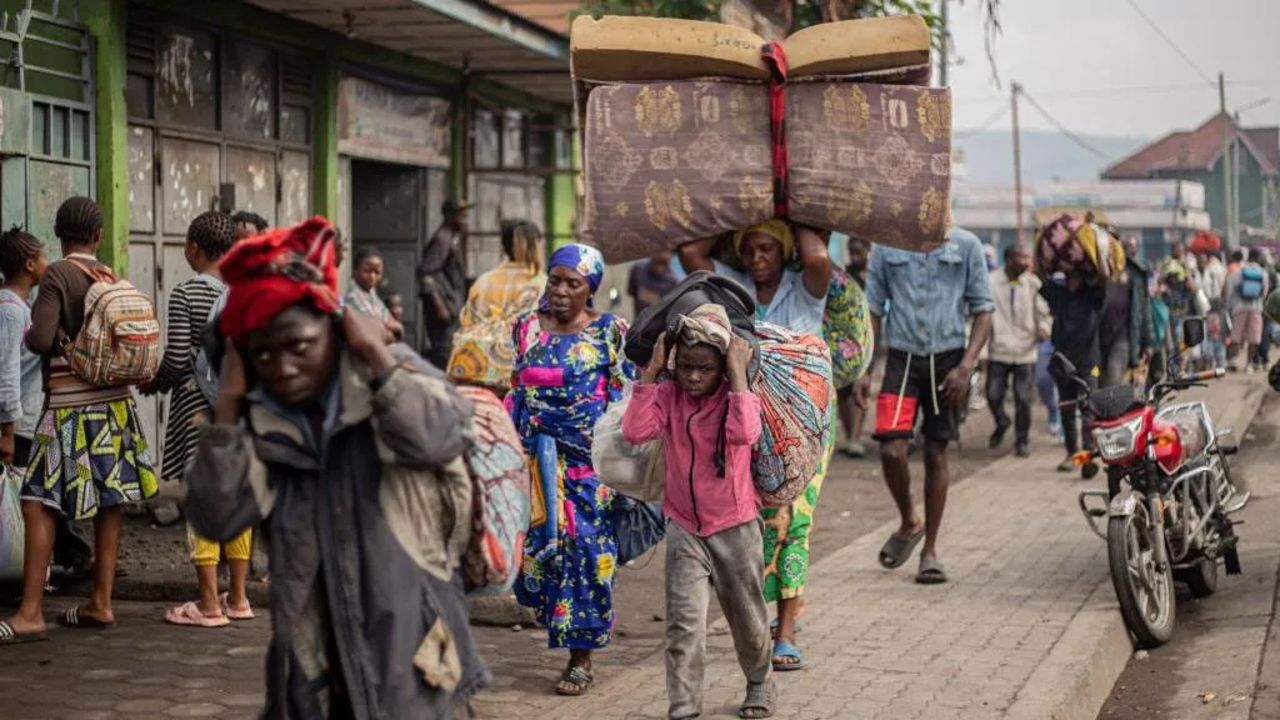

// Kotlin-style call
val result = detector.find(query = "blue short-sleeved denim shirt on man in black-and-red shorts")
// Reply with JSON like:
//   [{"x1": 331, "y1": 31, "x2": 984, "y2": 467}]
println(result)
[{"x1": 867, "y1": 228, "x2": 995, "y2": 355}]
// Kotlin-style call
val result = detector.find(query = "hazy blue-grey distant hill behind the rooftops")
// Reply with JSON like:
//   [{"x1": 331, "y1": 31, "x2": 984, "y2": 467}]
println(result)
[{"x1": 955, "y1": 129, "x2": 1148, "y2": 184}]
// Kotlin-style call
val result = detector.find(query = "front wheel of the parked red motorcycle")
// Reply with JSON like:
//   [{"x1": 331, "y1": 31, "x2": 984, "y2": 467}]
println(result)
[{"x1": 1107, "y1": 502, "x2": 1175, "y2": 650}]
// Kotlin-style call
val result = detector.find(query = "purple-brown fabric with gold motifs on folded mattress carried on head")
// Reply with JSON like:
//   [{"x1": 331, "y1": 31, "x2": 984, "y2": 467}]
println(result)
[{"x1": 584, "y1": 79, "x2": 951, "y2": 263}]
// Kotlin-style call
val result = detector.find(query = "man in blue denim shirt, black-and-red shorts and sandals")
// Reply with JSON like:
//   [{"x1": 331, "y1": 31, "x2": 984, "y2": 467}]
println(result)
[{"x1": 867, "y1": 228, "x2": 995, "y2": 584}]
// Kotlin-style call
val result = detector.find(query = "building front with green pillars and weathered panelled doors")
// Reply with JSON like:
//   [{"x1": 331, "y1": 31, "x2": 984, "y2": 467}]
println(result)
[{"x1": 0, "y1": 0, "x2": 577, "y2": 453}]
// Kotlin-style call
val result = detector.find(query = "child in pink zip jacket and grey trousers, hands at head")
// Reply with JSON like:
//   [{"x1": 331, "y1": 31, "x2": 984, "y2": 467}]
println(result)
[{"x1": 622, "y1": 305, "x2": 777, "y2": 719}]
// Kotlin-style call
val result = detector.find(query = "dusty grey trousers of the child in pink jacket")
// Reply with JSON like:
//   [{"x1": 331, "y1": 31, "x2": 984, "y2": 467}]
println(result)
[{"x1": 667, "y1": 519, "x2": 772, "y2": 717}]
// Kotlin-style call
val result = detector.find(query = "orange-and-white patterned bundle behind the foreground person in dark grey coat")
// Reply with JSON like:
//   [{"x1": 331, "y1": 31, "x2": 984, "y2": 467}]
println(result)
[{"x1": 458, "y1": 387, "x2": 530, "y2": 594}]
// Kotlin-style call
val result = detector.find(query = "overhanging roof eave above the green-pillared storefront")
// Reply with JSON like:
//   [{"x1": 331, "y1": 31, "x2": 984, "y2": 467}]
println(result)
[{"x1": 250, "y1": 0, "x2": 573, "y2": 105}]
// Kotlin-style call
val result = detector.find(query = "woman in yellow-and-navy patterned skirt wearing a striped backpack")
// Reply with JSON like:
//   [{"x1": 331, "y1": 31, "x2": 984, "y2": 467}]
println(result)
[{"x1": 0, "y1": 197, "x2": 157, "y2": 644}]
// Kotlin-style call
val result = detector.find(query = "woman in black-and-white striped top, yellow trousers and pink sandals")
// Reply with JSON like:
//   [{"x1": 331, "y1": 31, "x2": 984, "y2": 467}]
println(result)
[{"x1": 142, "y1": 210, "x2": 253, "y2": 628}]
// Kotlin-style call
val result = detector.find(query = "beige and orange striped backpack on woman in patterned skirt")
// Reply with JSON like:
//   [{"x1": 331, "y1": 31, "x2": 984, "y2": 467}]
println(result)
[{"x1": 63, "y1": 260, "x2": 163, "y2": 387}]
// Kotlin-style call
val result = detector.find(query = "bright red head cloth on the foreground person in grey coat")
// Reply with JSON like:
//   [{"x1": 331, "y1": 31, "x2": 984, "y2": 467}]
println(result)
[{"x1": 218, "y1": 215, "x2": 340, "y2": 341}]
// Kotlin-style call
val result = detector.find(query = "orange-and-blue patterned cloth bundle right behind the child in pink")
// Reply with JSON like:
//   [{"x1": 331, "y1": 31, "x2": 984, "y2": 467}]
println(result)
[{"x1": 750, "y1": 323, "x2": 835, "y2": 507}]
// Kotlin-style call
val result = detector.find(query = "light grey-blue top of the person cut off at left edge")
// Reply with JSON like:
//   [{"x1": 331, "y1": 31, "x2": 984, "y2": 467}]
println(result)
[{"x1": 0, "y1": 290, "x2": 45, "y2": 438}]
